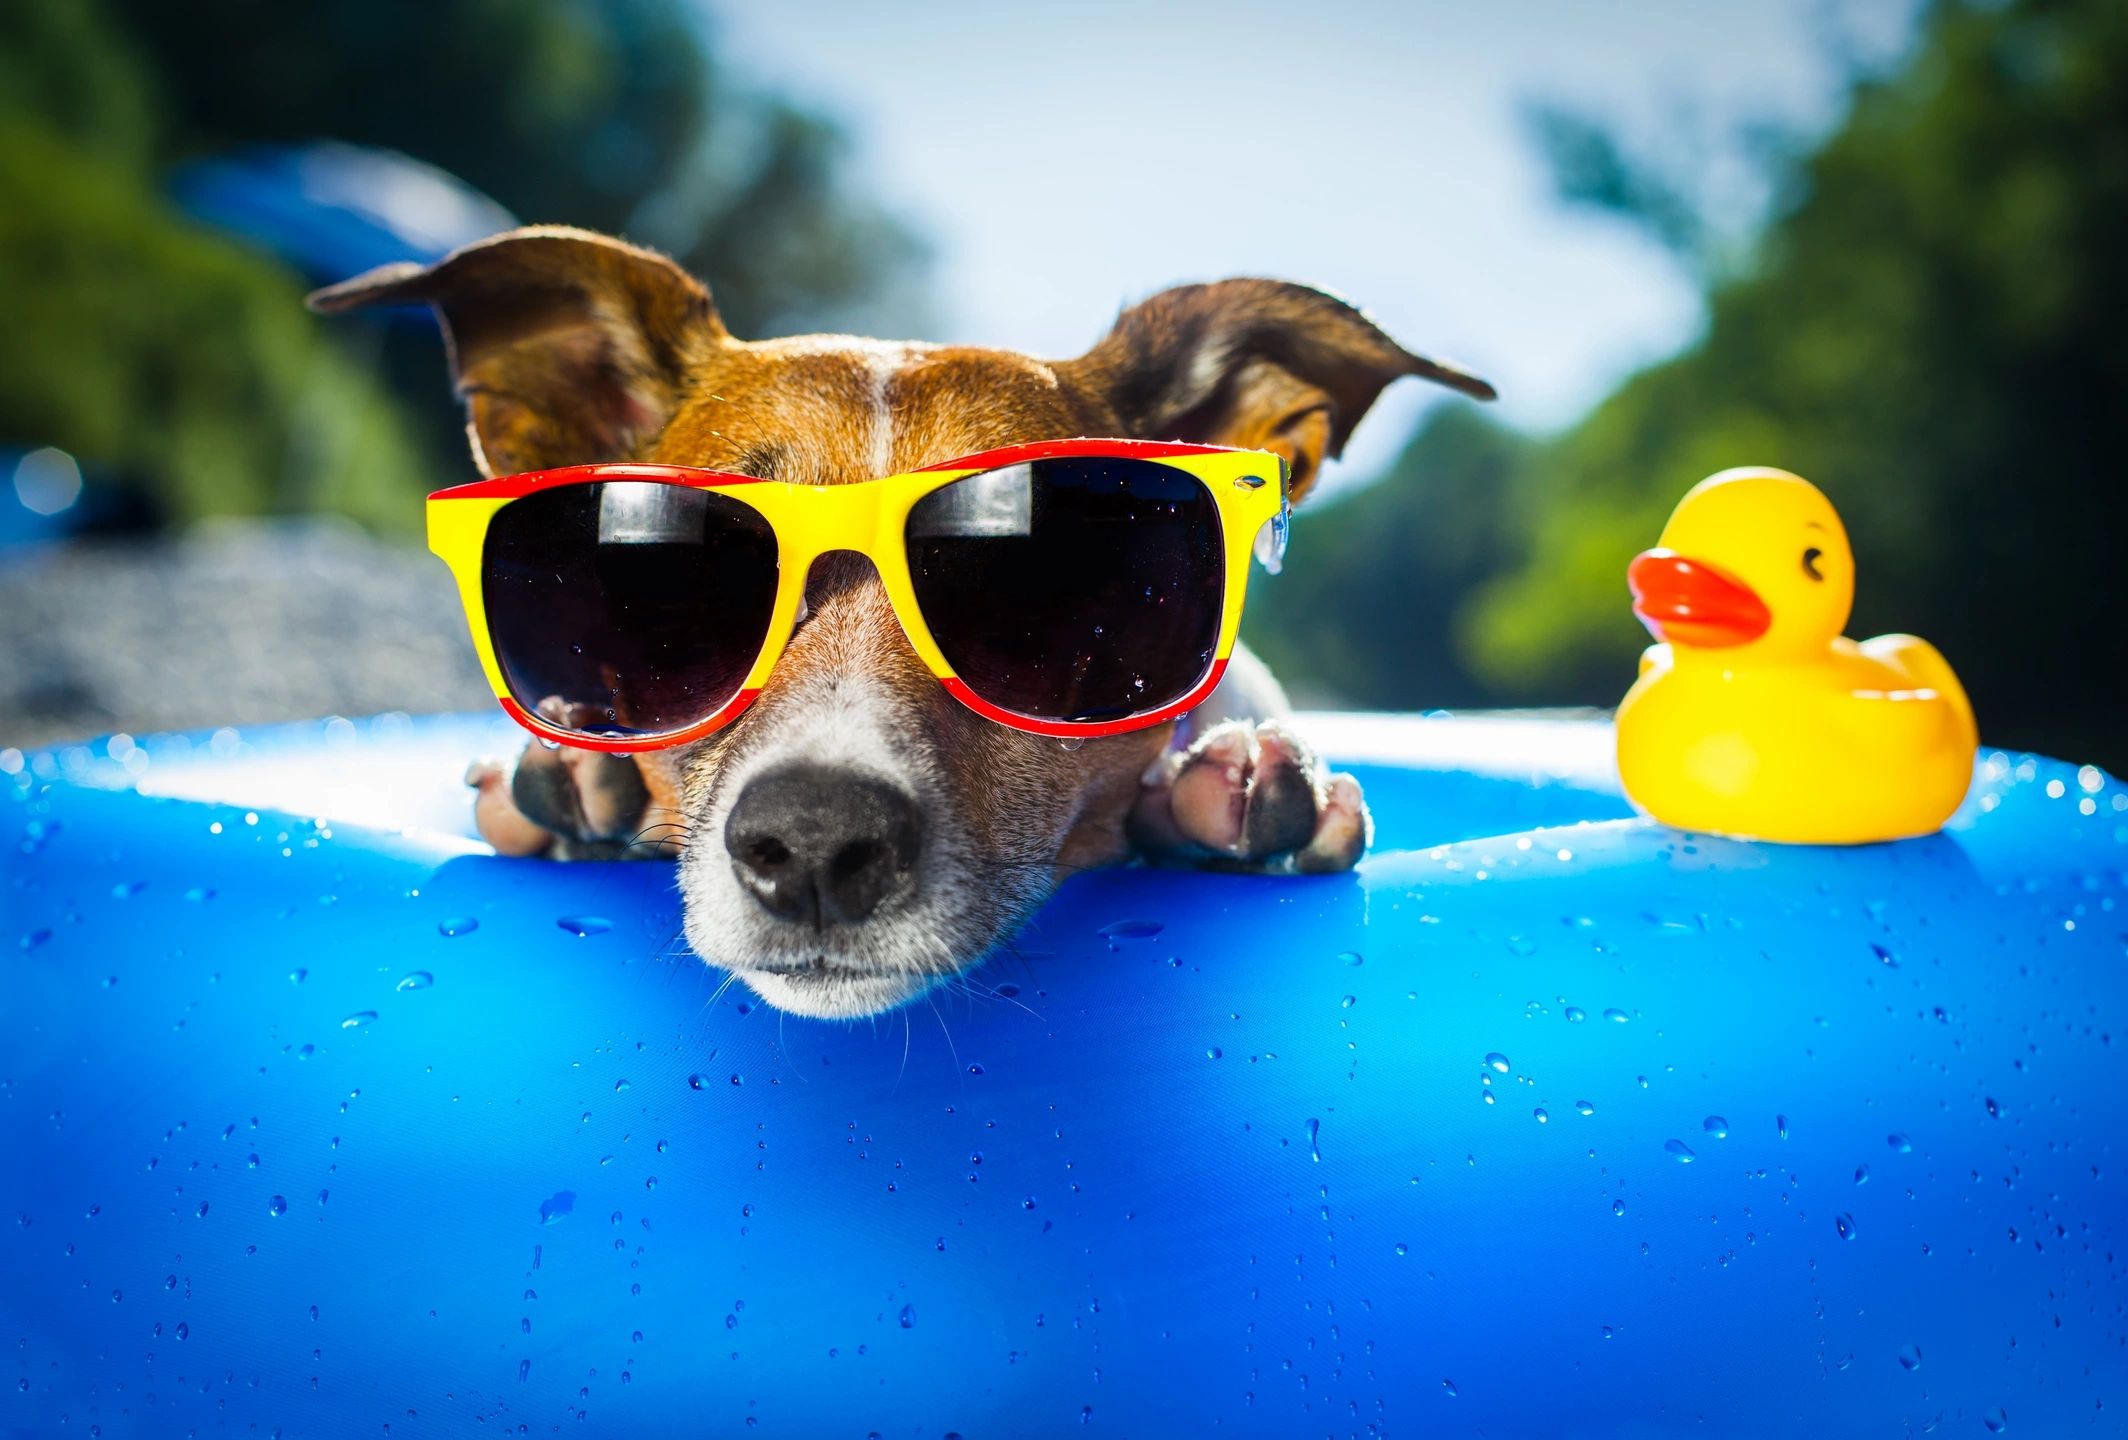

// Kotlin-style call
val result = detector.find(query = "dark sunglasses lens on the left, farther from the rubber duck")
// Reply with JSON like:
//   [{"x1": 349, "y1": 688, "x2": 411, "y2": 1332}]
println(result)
[{"x1": 481, "y1": 481, "x2": 777, "y2": 736}]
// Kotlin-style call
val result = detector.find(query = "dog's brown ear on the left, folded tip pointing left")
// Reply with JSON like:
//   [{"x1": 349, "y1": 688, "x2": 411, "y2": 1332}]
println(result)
[{"x1": 309, "y1": 225, "x2": 730, "y2": 476}]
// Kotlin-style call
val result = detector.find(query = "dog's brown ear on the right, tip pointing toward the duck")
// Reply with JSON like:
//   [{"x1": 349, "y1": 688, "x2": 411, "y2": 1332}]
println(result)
[{"x1": 1058, "y1": 281, "x2": 1494, "y2": 496}]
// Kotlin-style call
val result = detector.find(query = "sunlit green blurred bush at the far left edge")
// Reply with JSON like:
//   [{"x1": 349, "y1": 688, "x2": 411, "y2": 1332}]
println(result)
[{"x1": 0, "y1": 0, "x2": 428, "y2": 525}]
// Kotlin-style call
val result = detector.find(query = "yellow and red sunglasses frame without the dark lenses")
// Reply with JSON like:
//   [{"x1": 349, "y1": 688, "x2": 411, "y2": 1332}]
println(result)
[{"x1": 428, "y1": 440, "x2": 1290, "y2": 753}]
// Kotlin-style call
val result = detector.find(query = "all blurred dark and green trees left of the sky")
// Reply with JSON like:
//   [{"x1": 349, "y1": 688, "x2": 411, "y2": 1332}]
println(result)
[{"x1": 0, "y1": 0, "x2": 926, "y2": 530}]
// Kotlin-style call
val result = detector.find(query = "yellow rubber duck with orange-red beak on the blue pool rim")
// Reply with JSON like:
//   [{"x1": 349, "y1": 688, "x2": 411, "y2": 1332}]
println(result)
[{"x1": 1617, "y1": 468, "x2": 1979, "y2": 844}]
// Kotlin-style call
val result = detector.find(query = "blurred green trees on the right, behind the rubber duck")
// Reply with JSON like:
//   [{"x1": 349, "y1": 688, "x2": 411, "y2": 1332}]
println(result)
[{"x1": 1249, "y1": 0, "x2": 2128, "y2": 770}]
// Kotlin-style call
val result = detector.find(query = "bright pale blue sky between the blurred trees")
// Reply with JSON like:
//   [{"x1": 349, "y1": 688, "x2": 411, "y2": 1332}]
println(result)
[{"x1": 704, "y1": 0, "x2": 1913, "y2": 483}]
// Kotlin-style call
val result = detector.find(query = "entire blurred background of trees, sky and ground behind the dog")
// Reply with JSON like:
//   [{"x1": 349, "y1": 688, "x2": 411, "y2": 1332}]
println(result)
[{"x1": 0, "y1": 0, "x2": 2128, "y2": 768}]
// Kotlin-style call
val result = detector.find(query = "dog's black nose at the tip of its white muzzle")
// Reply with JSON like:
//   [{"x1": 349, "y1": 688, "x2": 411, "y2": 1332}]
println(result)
[{"x1": 724, "y1": 766, "x2": 924, "y2": 925}]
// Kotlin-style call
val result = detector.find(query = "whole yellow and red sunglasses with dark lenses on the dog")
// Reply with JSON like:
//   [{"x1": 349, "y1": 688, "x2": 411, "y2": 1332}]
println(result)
[{"x1": 428, "y1": 440, "x2": 1287, "y2": 751}]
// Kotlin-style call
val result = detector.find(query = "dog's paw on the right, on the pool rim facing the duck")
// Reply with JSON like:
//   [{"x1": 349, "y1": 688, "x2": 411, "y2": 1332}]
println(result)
[{"x1": 1130, "y1": 721, "x2": 1375, "y2": 874}]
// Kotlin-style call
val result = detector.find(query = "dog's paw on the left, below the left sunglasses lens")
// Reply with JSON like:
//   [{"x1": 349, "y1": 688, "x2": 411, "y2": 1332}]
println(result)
[{"x1": 466, "y1": 700, "x2": 666, "y2": 859}]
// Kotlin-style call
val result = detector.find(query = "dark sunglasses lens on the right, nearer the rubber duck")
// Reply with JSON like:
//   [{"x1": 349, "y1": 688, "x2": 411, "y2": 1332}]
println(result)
[{"x1": 907, "y1": 457, "x2": 1226, "y2": 723}]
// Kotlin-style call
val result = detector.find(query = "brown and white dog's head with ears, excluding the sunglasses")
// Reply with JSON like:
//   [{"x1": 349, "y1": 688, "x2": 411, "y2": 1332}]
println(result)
[{"x1": 319, "y1": 228, "x2": 1490, "y2": 1015}]
